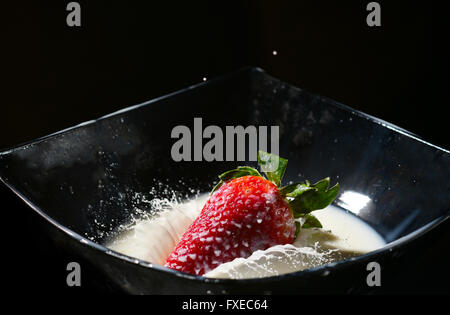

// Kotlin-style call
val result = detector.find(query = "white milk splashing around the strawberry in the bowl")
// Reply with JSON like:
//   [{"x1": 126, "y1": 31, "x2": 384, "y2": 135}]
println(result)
[{"x1": 105, "y1": 195, "x2": 385, "y2": 279}]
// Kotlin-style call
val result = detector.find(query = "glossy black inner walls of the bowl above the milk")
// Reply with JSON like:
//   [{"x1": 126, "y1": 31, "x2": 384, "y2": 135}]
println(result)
[{"x1": 0, "y1": 68, "x2": 450, "y2": 254}]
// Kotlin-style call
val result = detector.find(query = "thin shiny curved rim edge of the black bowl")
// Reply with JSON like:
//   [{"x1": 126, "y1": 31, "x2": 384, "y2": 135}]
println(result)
[{"x1": 0, "y1": 67, "x2": 450, "y2": 285}]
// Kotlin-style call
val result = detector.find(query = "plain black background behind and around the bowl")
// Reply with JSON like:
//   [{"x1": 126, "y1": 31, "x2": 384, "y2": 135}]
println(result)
[{"x1": 0, "y1": 0, "x2": 450, "y2": 293}]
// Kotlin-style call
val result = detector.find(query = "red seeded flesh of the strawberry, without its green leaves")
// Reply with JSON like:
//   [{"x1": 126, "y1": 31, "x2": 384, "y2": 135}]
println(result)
[{"x1": 165, "y1": 175, "x2": 295, "y2": 275}]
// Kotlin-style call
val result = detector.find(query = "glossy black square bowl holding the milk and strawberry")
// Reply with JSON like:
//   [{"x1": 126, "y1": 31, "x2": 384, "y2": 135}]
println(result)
[{"x1": 0, "y1": 68, "x2": 450, "y2": 294}]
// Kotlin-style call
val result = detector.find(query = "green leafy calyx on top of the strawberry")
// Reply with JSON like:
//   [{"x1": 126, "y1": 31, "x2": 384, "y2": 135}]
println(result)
[{"x1": 211, "y1": 151, "x2": 339, "y2": 235}]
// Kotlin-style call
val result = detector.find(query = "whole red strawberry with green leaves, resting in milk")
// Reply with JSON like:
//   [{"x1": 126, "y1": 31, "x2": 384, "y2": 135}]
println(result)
[{"x1": 164, "y1": 151, "x2": 339, "y2": 275}]
